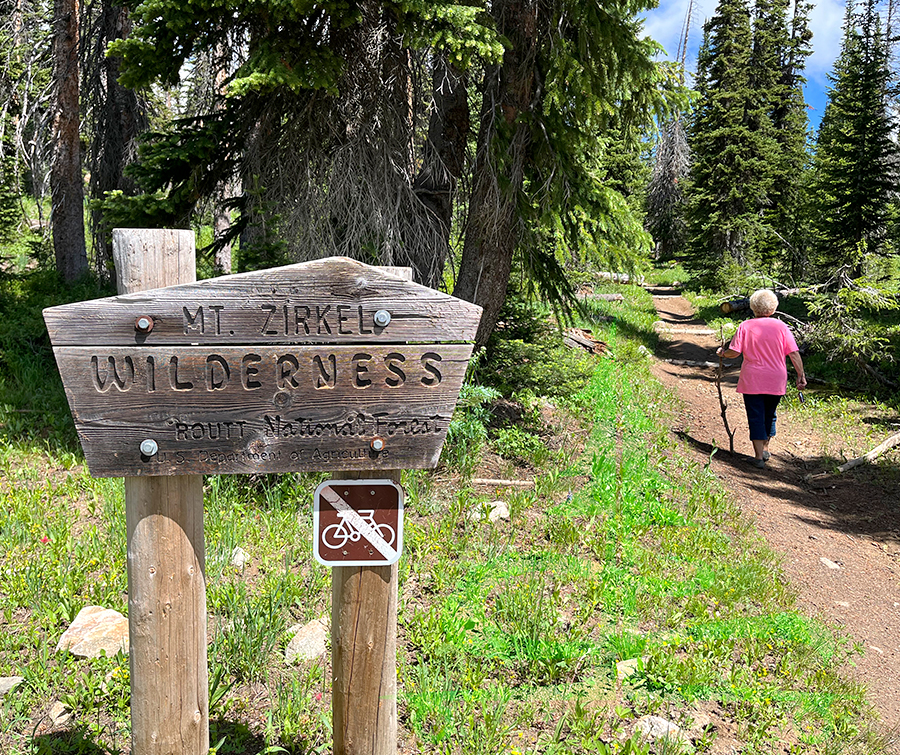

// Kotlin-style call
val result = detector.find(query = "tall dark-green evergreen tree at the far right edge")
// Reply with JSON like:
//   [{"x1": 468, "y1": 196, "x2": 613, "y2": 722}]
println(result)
[{"x1": 816, "y1": 0, "x2": 897, "y2": 276}]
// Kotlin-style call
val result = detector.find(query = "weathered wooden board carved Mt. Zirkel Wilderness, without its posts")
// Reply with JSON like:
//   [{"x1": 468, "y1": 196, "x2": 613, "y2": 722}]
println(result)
[{"x1": 44, "y1": 257, "x2": 481, "y2": 477}]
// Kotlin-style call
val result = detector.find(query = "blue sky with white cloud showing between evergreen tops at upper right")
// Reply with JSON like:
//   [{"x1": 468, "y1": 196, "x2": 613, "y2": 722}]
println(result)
[{"x1": 644, "y1": 0, "x2": 844, "y2": 133}]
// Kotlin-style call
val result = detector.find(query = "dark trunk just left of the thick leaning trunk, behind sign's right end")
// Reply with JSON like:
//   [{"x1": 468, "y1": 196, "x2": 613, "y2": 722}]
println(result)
[{"x1": 413, "y1": 55, "x2": 471, "y2": 288}]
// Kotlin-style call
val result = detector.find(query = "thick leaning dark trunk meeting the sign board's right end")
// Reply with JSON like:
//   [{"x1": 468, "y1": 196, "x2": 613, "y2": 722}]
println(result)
[{"x1": 453, "y1": 0, "x2": 538, "y2": 346}]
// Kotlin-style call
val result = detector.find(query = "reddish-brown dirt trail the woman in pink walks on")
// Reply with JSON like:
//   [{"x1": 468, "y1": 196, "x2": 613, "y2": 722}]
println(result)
[{"x1": 651, "y1": 288, "x2": 900, "y2": 727}]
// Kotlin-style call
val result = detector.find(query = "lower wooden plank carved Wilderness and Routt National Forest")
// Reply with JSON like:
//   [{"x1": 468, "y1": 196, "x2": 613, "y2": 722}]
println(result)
[{"x1": 56, "y1": 344, "x2": 472, "y2": 477}]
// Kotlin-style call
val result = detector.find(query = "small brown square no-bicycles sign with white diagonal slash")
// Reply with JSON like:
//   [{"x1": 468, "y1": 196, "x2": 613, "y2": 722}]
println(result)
[{"x1": 313, "y1": 480, "x2": 403, "y2": 566}]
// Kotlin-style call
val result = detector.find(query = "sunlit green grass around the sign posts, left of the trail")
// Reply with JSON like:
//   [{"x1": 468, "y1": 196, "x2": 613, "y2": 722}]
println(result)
[{"x1": 0, "y1": 272, "x2": 886, "y2": 755}]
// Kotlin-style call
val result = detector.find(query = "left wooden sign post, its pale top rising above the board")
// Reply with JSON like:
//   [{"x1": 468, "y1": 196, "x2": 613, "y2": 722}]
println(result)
[{"x1": 113, "y1": 229, "x2": 209, "y2": 755}]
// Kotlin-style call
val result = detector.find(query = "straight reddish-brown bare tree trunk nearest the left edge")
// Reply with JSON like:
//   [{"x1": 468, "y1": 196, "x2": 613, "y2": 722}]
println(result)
[{"x1": 50, "y1": 0, "x2": 88, "y2": 283}]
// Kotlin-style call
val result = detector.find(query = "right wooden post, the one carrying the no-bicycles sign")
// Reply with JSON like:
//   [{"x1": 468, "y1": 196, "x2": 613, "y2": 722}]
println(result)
[{"x1": 331, "y1": 471, "x2": 400, "y2": 755}]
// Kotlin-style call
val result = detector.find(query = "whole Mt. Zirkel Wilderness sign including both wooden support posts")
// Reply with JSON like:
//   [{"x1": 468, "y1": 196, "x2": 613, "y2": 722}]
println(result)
[{"x1": 44, "y1": 230, "x2": 481, "y2": 755}]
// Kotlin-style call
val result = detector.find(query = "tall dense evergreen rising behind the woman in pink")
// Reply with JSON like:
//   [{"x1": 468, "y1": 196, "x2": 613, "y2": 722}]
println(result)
[{"x1": 687, "y1": 0, "x2": 811, "y2": 284}]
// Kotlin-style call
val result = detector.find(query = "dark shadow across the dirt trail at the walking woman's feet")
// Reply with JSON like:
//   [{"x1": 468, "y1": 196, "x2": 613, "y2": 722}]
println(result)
[{"x1": 674, "y1": 430, "x2": 900, "y2": 542}]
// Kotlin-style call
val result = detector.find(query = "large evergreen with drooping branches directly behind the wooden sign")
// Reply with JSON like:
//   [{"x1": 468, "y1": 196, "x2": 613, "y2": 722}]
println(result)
[{"x1": 105, "y1": 0, "x2": 683, "y2": 342}]
